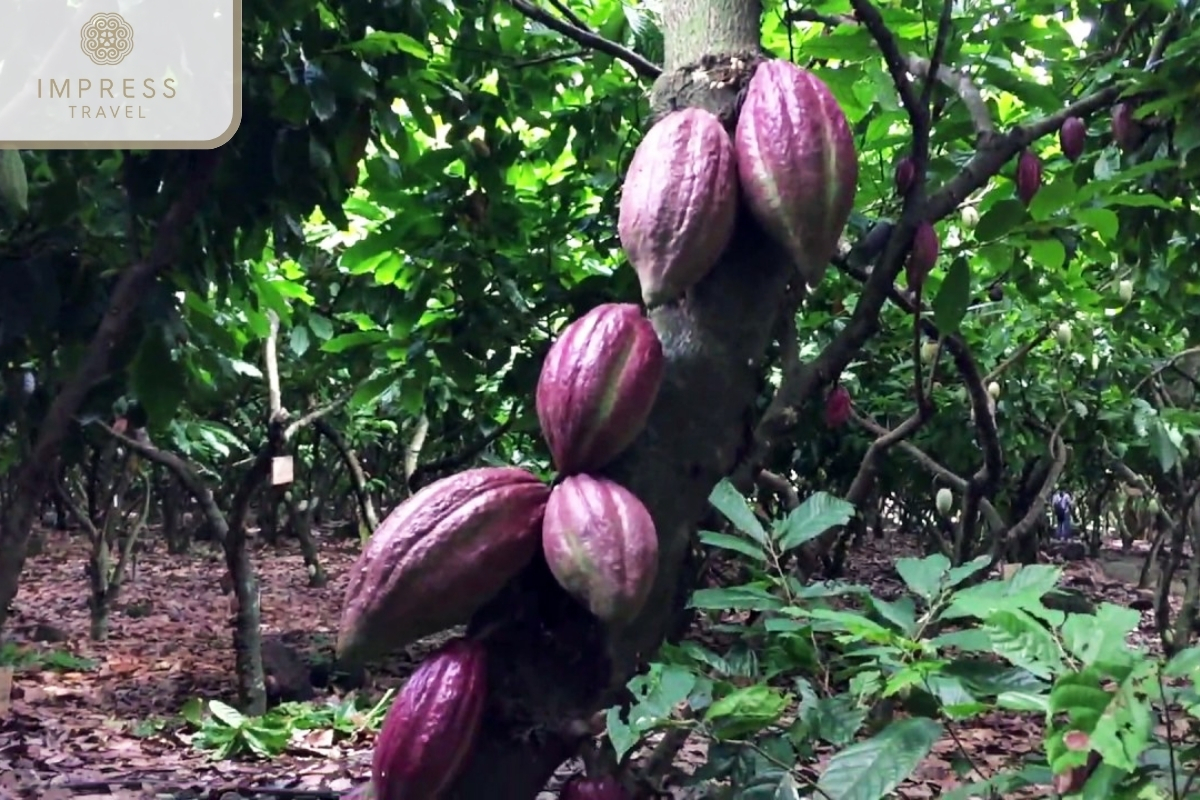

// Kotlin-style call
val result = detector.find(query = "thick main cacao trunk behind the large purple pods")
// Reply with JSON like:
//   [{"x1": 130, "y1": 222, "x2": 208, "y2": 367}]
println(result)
[{"x1": 448, "y1": 0, "x2": 792, "y2": 800}]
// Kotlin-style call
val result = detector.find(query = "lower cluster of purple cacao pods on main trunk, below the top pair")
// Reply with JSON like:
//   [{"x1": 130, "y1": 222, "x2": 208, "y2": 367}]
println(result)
[{"x1": 337, "y1": 303, "x2": 664, "y2": 800}]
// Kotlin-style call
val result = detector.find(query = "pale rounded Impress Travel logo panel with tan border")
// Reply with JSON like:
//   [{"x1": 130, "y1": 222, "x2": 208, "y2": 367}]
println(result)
[{"x1": 0, "y1": 0, "x2": 241, "y2": 149}]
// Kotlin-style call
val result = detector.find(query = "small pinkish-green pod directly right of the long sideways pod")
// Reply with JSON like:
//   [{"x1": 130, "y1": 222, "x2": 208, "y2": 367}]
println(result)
[{"x1": 541, "y1": 475, "x2": 659, "y2": 625}]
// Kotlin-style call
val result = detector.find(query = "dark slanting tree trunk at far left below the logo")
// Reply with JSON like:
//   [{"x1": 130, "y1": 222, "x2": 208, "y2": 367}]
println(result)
[{"x1": 0, "y1": 150, "x2": 220, "y2": 631}]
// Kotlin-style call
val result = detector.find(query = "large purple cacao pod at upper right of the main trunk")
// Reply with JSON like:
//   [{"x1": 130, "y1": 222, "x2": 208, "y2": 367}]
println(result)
[{"x1": 734, "y1": 60, "x2": 858, "y2": 287}]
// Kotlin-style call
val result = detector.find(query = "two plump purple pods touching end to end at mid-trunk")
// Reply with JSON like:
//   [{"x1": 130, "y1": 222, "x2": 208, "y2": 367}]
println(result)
[{"x1": 538, "y1": 303, "x2": 664, "y2": 625}]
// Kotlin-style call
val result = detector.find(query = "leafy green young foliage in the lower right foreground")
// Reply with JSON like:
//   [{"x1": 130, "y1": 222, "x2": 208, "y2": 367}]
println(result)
[{"x1": 607, "y1": 483, "x2": 1200, "y2": 800}]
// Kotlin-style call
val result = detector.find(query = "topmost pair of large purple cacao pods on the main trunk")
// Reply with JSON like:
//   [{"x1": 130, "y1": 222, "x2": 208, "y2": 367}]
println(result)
[{"x1": 617, "y1": 60, "x2": 858, "y2": 299}]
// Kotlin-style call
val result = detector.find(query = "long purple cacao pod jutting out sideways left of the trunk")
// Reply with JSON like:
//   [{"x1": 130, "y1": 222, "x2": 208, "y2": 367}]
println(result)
[{"x1": 337, "y1": 467, "x2": 550, "y2": 662}]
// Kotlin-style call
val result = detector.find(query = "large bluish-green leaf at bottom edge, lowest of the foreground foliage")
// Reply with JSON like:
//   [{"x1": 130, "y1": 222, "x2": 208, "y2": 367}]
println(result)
[{"x1": 817, "y1": 717, "x2": 942, "y2": 800}]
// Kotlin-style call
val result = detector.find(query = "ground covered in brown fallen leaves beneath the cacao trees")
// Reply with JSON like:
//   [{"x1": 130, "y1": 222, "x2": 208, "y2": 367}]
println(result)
[{"x1": 0, "y1": 533, "x2": 1185, "y2": 800}]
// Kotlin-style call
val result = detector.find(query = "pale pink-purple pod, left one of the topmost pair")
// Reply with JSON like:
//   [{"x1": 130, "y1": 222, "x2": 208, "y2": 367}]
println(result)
[{"x1": 617, "y1": 108, "x2": 738, "y2": 306}]
